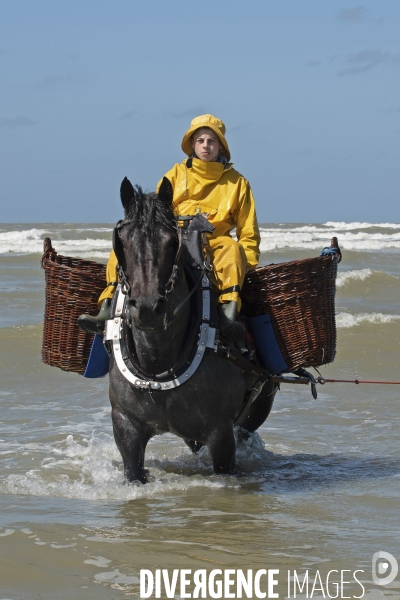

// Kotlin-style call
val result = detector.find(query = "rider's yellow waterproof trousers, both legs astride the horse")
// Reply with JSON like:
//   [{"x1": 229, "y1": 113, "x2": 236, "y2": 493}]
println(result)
[{"x1": 99, "y1": 235, "x2": 247, "y2": 309}]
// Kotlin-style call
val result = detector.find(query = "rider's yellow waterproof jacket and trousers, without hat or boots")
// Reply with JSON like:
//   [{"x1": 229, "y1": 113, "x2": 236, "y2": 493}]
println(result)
[{"x1": 99, "y1": 158, "x2": 260, "y2": 302}]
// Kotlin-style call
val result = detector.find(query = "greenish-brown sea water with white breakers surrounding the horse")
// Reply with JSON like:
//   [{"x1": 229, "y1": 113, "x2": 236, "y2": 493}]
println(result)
[{"x1": 0, "y1": 223, "x2": 400, "y2": 600}]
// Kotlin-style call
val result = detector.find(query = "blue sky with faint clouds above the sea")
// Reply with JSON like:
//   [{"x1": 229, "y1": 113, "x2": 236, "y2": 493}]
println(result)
[{"x1": 0, "y1": 0, "x2": 400, "y2": 223}]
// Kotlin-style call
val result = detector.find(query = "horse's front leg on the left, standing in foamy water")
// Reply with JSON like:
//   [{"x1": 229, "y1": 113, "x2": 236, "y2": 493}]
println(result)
[{"x1": 112, "y1": 409, "x2": 151, "y2": 483}]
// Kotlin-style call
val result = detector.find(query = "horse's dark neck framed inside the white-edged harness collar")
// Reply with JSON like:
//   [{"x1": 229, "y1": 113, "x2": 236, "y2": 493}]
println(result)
[{"x1": 132, "y1": 273, "x2": 190, "y2": 373}]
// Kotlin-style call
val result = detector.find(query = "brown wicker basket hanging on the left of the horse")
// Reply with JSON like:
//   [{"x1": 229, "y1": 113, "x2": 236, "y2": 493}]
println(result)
[{"x1": 41, "y1": 238, "x2": 106, "y2": 374}]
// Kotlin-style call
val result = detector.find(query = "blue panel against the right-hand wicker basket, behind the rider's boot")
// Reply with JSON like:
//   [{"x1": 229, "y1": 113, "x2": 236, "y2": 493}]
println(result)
[{"x1": 249, "y1": 315, "x2": 288, "y2": 375}]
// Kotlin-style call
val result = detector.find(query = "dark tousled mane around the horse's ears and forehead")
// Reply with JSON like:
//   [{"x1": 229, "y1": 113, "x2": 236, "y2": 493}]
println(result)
[{"x1": 125, "y1": 185, "x2": 177, "y2": 237}]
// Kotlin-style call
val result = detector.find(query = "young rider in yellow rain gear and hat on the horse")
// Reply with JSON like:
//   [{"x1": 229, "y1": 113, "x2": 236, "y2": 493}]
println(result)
[{"x1": 79, "y1": 114, "x2": 260, "y2": 341}]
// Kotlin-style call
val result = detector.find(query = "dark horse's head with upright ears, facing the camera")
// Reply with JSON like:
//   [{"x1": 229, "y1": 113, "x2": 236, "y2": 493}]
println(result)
[{"x1": 114, "y1": 177, "x2": 180, "y2": 331}]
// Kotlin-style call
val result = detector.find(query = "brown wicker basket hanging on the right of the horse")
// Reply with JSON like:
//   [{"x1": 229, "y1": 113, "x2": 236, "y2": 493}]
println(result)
[{"x1": 241, "y1": 254, "x2": 340, "y2": 370}]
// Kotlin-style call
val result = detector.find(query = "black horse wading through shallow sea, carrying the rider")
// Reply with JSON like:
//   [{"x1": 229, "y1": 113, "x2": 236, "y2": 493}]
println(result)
[{"x1": 110, "y1": 178, "x2": 277, "y2": 483}]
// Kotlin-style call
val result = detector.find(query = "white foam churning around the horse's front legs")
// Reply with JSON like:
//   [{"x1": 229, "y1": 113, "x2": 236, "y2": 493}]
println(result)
[{"x1": 0, "y1": 434, "x2": 225, "y2": 500}]
